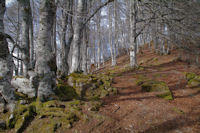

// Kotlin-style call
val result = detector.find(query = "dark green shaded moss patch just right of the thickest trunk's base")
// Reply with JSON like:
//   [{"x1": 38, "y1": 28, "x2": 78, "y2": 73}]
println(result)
[{"x1": 55, "y1": 84, "x2": 78, "y2": 101}]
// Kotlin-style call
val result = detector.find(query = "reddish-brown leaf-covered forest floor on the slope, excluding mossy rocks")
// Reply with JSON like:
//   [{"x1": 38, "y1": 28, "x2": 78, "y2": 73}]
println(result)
[{"x1": 64, "y1": 50, "x2": 200, "y2": 133}]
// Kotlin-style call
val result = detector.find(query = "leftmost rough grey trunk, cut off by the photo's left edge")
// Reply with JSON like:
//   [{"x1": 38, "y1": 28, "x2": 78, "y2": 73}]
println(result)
[{"x1": 0, "y1": 0, "x2": 15, "y2": 112}]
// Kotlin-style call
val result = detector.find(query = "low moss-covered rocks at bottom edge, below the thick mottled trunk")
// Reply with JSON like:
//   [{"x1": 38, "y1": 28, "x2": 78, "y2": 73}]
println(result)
[{"x1": 26, "y1": 100, "x2": 83, "y2": 133}]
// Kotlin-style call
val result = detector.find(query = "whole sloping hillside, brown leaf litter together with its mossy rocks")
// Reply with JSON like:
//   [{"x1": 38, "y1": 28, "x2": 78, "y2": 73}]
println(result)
[{"x1": 0, "y1": 49, "x2": 200, "y2": 133}]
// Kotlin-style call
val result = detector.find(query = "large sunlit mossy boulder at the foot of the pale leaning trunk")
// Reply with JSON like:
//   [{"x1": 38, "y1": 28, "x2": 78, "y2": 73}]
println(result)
[{"x1": 67, "y1": 73, "x2": 117, "y2": 99}]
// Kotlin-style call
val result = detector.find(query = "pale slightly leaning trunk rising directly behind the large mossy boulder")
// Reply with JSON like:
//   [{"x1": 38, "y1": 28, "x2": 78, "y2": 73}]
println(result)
[{"x1": 70, "y1": 0, "x2": 86, "y2": 73}]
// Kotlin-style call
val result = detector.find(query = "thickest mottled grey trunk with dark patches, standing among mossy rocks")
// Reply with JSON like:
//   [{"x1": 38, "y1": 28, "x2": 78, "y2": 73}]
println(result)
[{"x1": 35, "y1": 0, "x2": 57, "y2": 101}]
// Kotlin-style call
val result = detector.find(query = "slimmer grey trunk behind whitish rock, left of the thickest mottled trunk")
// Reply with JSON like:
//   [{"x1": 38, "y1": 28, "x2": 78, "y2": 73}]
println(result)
[{"x1": 18, "y1": 0, "x2": 32, "y2": 77}]
